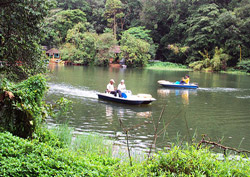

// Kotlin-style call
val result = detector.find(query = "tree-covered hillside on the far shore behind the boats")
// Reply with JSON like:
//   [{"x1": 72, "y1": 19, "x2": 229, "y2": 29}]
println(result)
[{"x1": 39, "y1": 0, "x2": 250, "y2": 70}]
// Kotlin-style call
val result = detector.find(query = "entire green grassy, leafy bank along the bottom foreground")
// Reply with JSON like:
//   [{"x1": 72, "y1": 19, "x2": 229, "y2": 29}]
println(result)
[{"x1": 0, "y1": 128, "x2": 250, "y2": 176}]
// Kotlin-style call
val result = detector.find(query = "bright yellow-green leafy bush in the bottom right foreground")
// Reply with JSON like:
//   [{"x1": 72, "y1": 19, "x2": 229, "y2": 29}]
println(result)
[{"x1": 114, "y1": 145, "x2": 250, "y2": 176}]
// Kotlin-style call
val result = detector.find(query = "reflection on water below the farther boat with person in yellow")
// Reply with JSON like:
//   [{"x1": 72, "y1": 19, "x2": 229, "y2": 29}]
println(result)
[{"x1": 157, "y1": 88, "x2": 197, "y2": 105}]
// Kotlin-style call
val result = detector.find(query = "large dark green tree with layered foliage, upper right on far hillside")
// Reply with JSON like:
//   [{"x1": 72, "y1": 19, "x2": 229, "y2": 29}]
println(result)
[{"x1": 185, "y1": 4, "x2": 220, "y2": 62}]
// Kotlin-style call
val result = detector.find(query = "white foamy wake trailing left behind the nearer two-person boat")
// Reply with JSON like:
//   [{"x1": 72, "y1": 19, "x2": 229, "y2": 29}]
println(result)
[{"x1": 48, "y1": 83, "x2": 98, "y2": 99}]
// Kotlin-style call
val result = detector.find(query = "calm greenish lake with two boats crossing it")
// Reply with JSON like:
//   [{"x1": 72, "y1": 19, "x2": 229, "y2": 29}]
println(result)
[{"x1": 46, "y1": 65, "x2": 250, "y2": 150}]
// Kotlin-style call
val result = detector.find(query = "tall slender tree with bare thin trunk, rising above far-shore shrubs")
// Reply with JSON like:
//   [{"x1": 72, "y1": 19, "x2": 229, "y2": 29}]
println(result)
[{"x1": 104, "y1": 0, "x2": 124, "y2": 39}]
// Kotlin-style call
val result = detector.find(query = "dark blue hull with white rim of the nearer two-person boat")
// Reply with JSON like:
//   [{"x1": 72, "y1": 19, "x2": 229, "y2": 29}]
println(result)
[{"x1": 97, "y1": 93, "x2": 155, "y2": 105}]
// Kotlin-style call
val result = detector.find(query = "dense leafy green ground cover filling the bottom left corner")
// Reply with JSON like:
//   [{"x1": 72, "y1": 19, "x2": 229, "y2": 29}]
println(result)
[{"x1": 0, "y1": 133, "x2": 117, "y2": 176}]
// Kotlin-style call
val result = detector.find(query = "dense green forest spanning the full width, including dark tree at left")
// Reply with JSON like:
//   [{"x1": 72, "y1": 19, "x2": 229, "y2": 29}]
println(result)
[{"x1": 0, "y1": 0, "x2": 250, "y2": 79}]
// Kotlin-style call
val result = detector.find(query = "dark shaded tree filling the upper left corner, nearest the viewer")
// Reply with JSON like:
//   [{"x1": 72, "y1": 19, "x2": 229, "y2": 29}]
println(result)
[{"x1": 0, "y1": 0, "x2": 51, "y2": 80}]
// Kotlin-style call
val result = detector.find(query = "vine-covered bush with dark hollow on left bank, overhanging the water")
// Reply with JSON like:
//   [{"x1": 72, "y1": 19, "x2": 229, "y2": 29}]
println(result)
[{"x1": 0, "y1": 75, "x2": 70, "y2": 138}]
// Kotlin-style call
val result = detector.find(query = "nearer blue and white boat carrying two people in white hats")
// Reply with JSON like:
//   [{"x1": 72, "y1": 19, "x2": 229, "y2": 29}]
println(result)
[{"x1": 97, "y1": 93, "x2": 156, "y2": 105}]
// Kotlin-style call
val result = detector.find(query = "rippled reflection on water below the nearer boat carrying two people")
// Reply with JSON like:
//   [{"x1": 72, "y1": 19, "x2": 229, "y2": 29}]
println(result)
[{"x1": 105, "y1": 103, "x2": 152, "y2": 123}]
